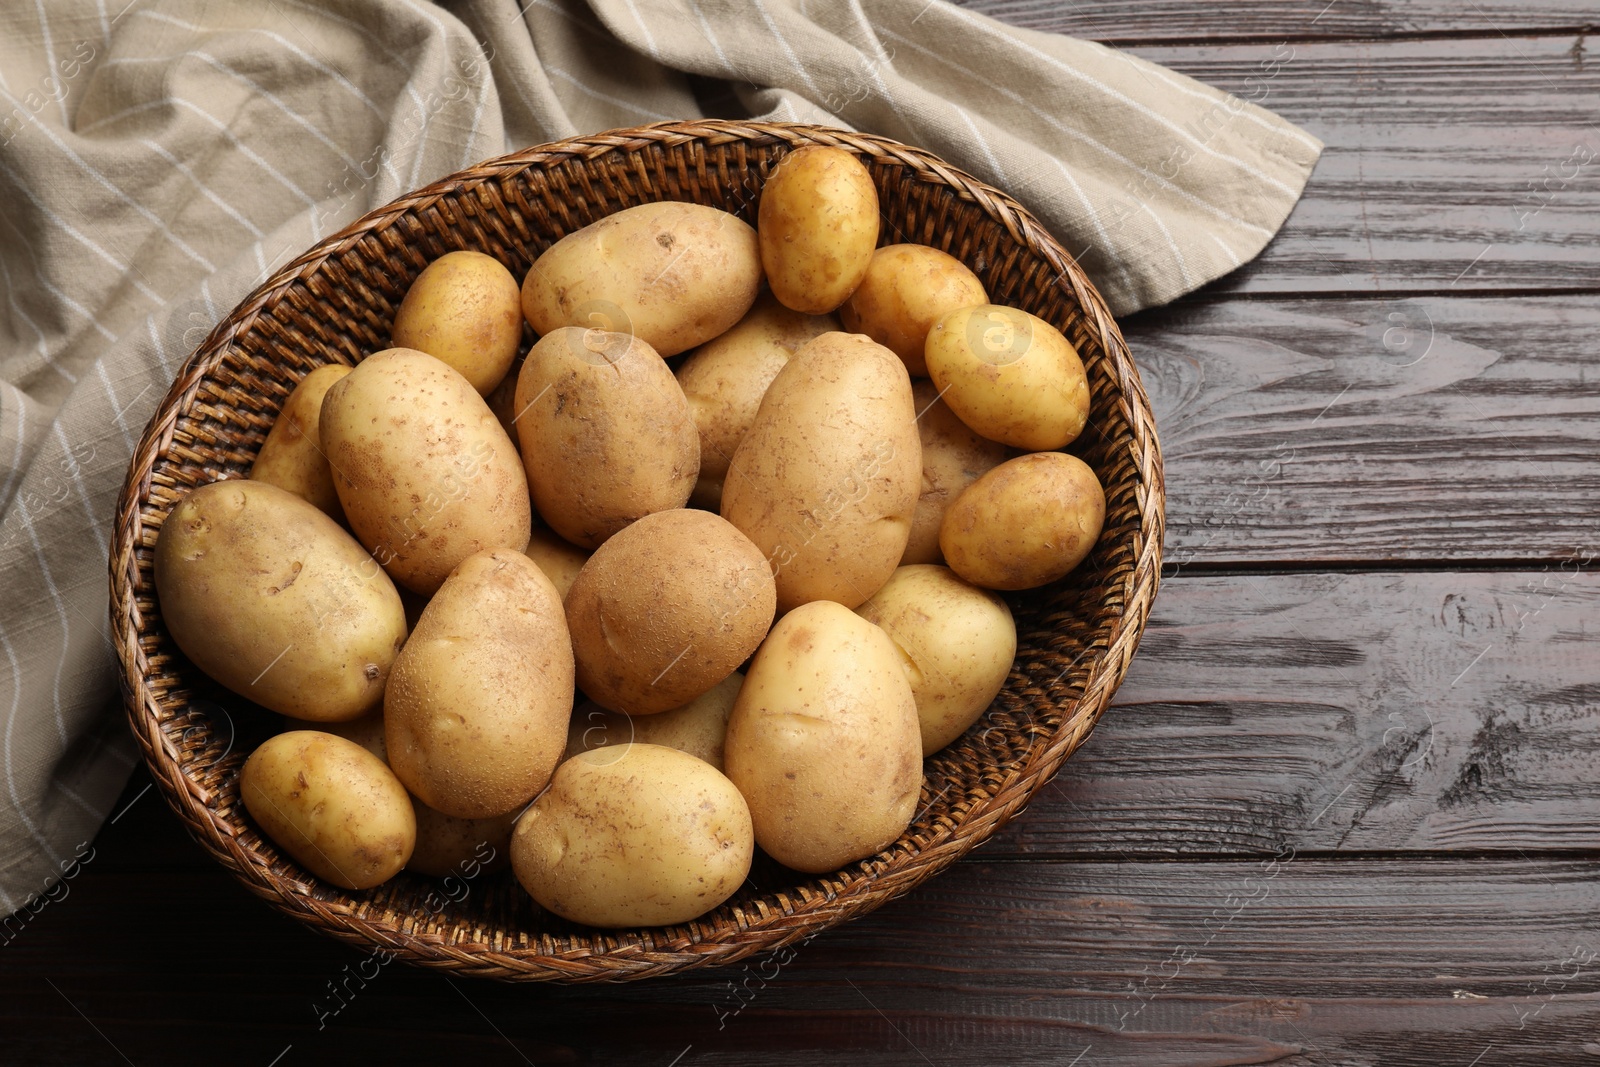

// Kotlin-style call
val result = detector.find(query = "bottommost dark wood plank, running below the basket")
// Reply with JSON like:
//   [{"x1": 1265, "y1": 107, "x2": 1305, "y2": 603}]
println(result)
[{"x1": 0, "y1": 853, "x2": 1600, "y2": 1067}]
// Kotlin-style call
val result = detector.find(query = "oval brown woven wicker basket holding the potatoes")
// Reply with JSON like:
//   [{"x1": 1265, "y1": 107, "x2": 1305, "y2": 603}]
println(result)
[{"x1": 110, "y1": 120, "x2": 1163, "y2": 982}]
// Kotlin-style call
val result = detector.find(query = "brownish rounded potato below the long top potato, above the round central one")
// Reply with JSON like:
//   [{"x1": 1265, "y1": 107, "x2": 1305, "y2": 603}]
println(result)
[{"x1": 517, "y1": 328, "x2": 699, "y2": 549}]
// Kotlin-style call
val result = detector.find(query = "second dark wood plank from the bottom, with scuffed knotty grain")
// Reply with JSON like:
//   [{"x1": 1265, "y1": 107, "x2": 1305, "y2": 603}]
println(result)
[{"x1": 982, "y1": 566, "x2": 1600, "y2": 857}]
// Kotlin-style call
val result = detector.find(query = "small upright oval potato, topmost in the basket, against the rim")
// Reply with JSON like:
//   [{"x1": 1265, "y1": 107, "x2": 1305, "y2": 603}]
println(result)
[{"x1": 757, "y1": 144, "x2": 878, "y2": 315}]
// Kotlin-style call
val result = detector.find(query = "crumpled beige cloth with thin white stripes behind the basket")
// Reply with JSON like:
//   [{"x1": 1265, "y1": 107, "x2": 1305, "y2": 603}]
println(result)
[{"x1": 0, "y1": 0, "x2": 1320, "y2": 913}]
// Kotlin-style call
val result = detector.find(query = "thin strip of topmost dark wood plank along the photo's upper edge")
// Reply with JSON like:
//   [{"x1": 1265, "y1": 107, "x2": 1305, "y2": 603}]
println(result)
[{"x1": 957, "y1": 0, "x2": 1600, "y2": 43}]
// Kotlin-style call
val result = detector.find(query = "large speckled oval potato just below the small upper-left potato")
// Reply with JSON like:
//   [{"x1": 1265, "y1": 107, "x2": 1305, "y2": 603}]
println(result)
[{"x1": 322, "y1": 349, "x2": 531, "y2": 593}]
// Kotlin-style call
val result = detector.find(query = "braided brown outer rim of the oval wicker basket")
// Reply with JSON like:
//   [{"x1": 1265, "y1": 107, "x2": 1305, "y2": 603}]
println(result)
[{"x1": 110, "y1": 120, "x2": 1165, "y2": 981}]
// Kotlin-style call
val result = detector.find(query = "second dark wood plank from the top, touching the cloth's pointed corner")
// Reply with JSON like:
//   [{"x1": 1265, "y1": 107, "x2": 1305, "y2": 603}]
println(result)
[{"x1": 1131, "y1": 35, "x2": 1600, "y2": 293}]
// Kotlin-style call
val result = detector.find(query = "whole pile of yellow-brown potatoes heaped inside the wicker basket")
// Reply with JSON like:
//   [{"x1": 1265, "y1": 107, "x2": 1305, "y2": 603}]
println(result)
[{"x1": 155, "y1": 147, "x2": 1106, "y2": 928}]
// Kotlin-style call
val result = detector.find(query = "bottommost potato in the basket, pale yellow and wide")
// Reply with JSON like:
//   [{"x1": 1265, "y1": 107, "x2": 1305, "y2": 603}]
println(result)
[{"x1": 510, "y1": 744, "x2": 755, "y2": 928}]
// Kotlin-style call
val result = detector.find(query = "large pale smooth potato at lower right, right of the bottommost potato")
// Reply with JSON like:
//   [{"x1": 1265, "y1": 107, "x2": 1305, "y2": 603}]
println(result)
[{"x1": 726, "y1": 600, "x2": 922, "y2": 873}]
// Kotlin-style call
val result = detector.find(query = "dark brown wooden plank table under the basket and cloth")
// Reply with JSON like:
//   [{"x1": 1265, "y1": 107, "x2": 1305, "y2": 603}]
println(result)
[{"x1": 0, "y1": 0, "x2": 1600, "y2": 1067}]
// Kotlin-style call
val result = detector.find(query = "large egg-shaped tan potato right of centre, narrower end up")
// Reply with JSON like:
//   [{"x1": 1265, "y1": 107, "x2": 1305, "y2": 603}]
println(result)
[{"x1": 722, "y1": 333, "x2": 922, "y2": 613}]
